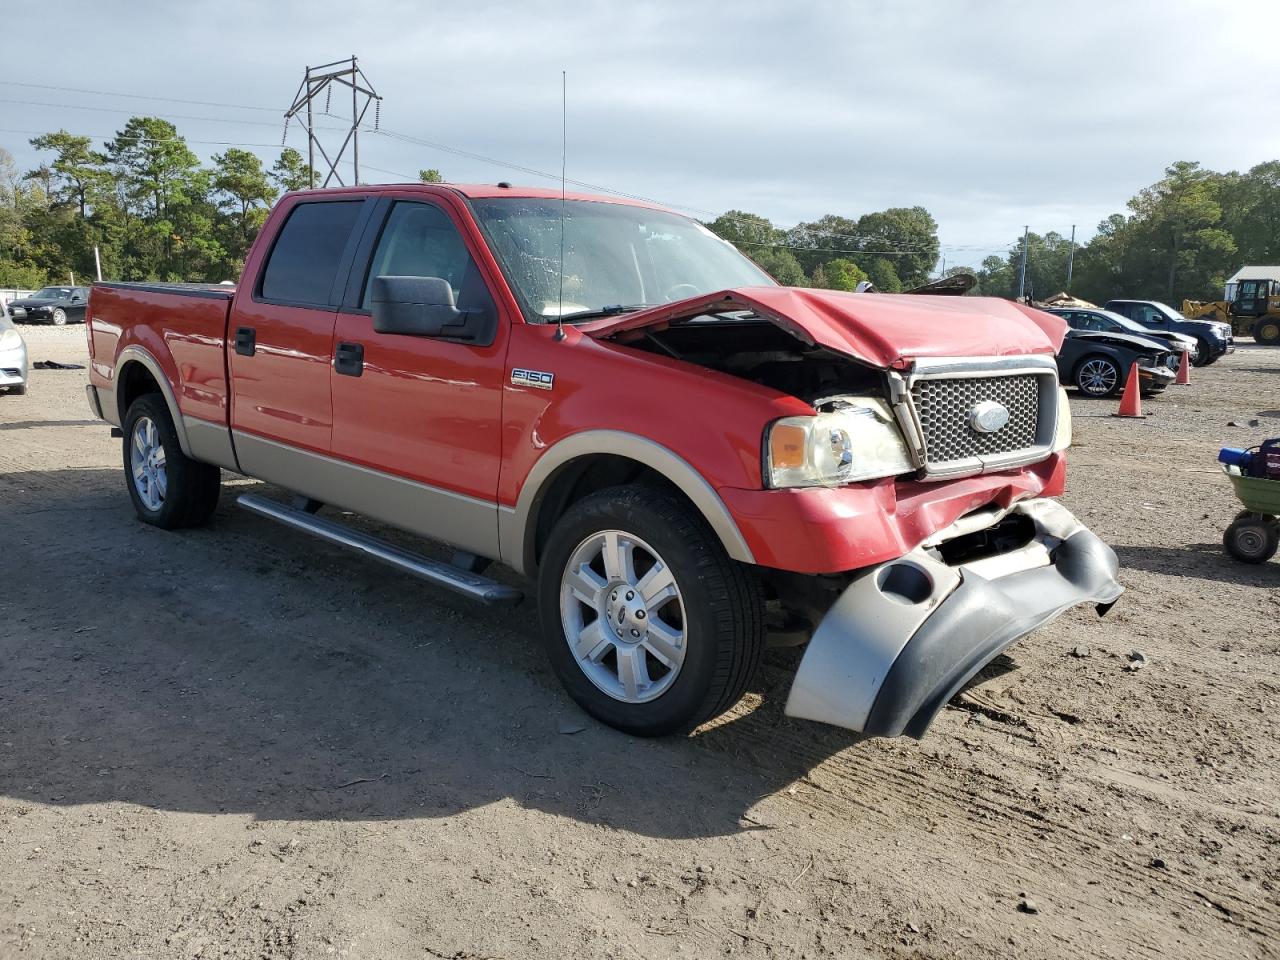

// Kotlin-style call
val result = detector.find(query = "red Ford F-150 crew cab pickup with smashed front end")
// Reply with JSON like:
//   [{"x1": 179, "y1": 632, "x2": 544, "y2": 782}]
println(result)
[{"x1": 87, "y1": 184, "x2": 1121, "y2": 737}]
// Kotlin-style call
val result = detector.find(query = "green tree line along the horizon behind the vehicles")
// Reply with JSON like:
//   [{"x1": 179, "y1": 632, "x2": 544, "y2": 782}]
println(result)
[{"x1": 0, "y1": 116, "x2": 1280, "y2": 303}]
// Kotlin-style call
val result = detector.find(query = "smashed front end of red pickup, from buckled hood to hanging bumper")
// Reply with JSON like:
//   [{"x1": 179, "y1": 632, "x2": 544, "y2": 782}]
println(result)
[{"x1": 594, "y1": 291, "x2": 1123, "y2": 737}]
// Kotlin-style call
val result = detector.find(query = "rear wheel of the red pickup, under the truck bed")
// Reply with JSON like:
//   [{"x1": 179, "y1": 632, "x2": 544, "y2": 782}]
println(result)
[{"x1": 123, "y1": 393, "x2": 221, "y2": 530}]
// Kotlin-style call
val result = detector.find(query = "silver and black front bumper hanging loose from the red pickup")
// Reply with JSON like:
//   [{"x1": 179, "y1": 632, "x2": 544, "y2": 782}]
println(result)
[{"x1": 786, "y1": 499, "x2": 1124, "y2": 739}]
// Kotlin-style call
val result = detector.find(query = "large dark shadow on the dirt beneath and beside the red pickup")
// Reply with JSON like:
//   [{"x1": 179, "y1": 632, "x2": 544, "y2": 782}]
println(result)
[{"x1": 0, "y1": 470, "x2": 874, "y2": 837}]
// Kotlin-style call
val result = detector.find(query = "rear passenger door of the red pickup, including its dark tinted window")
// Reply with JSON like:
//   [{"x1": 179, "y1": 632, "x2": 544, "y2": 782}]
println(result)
[{"x1": 227, "y1": 195, "x2": 372, "y2": 465}]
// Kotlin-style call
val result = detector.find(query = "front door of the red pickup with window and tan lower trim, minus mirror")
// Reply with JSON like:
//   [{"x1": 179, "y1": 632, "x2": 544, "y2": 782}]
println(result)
[{"x1": 332, "y1": 198, "x2": 512, "y2": 557}]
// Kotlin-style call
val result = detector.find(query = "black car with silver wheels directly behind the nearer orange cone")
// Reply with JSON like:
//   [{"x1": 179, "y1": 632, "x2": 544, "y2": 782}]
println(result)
[{"x1": 1057, "y1": 319, "x2": 1180, "y2": 397}]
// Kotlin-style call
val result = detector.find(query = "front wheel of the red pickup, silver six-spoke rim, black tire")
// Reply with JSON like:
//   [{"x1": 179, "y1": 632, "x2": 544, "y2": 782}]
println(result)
[{"x1": 538, "y1": 486, "x2": 764, "y2": 736}]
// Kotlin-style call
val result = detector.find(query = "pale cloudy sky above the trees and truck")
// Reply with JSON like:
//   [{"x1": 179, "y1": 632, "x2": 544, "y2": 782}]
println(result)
[{"x1": 0, "y1": 0, "x2": 1280, "y2": 265}]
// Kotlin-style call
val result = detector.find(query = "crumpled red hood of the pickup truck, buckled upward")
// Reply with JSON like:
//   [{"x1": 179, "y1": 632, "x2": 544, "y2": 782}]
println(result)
[{"x1": 579, "y1": 287, "x2": 1066, "y2": 367}]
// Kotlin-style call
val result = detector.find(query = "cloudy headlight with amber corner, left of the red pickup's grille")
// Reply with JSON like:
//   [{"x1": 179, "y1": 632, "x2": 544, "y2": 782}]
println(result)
[{"x1": 764, "y1": 397, "x2": 914, "y2": 488}]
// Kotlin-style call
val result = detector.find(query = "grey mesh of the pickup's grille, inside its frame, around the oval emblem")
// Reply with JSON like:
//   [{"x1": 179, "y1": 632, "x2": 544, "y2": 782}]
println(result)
[{"x1": 911, "y1": 374, "x2": 1042, "y2": 468}]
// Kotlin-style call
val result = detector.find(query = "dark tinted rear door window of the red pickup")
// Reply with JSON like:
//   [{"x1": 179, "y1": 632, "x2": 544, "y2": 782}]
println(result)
[{"x1": 261, "y1": 200, "x2": 364, "y2": 306}]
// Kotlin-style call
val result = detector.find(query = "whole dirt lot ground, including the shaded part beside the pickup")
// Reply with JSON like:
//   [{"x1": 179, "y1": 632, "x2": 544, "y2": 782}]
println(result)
[{"x1": 0, "y1": 326, "x2": 1280, "y2": 960}]
